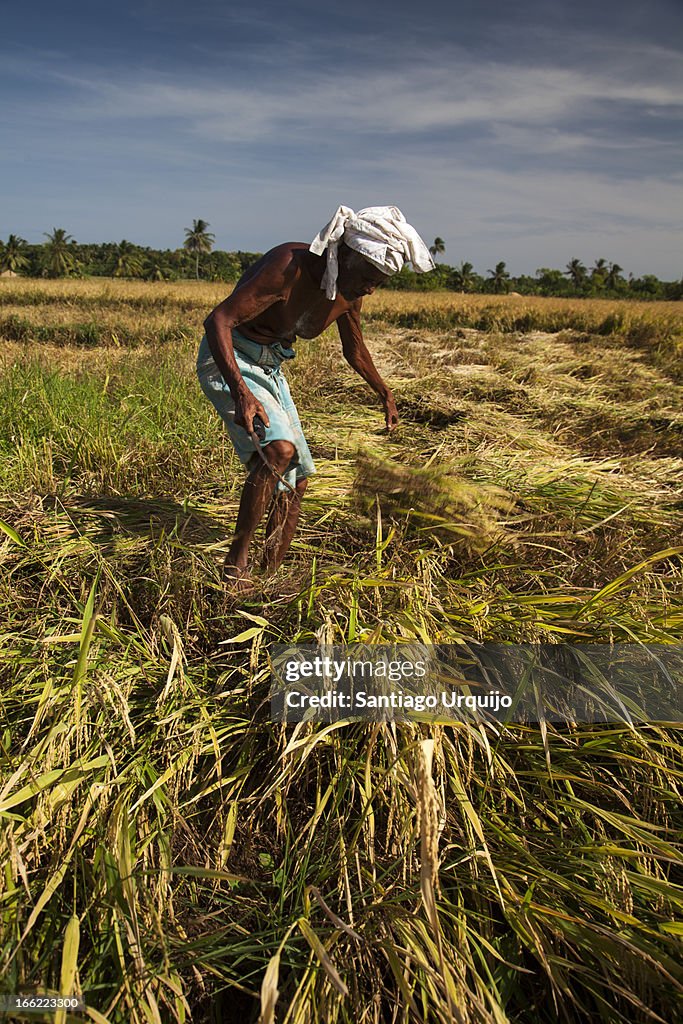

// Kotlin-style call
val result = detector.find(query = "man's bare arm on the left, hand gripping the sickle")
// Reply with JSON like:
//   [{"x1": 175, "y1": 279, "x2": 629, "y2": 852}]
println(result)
[{"x1": 204, "y1": 253, "x2": 296, "y2": 432}]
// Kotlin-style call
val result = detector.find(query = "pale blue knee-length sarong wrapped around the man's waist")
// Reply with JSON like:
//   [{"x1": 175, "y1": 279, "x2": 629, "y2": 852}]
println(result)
[{"x1": 197, "y1": 329, "x2": 315, "y2": 490}]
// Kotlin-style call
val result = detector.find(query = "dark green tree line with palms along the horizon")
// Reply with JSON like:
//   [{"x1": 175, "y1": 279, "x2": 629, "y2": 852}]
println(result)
[{"x1": 0, "y1": 219, "x2": 683, "y2": 300}]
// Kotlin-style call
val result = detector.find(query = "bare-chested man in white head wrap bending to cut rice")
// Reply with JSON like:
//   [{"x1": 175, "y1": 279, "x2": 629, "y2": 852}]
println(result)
[{"x1": 198, "y1": 207, "x2": 433, "y2": 580}]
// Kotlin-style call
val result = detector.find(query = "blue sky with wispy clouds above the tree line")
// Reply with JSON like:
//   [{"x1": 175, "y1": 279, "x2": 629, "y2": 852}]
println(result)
[{"x1": 0, "y1": 0, "x2": 683, "y2": 279}]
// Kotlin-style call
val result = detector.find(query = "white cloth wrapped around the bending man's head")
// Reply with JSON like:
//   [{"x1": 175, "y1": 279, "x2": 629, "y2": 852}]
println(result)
[{"x1": 308, "y1": 206, "x2": 434, "y2": 299}]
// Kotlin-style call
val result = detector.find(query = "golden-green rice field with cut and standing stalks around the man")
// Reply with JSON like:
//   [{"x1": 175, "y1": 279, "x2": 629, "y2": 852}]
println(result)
[{"x1": 0, "y1": 280, "x2": 683, "y2": 1024}]
